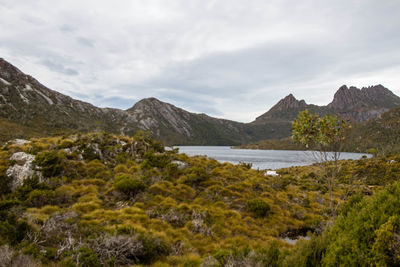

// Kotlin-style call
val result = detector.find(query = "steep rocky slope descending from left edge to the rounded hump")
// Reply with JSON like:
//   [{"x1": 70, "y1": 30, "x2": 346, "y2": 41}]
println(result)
[{"x1": 0, "y1": 59, "x2": 141, "y2": 138}]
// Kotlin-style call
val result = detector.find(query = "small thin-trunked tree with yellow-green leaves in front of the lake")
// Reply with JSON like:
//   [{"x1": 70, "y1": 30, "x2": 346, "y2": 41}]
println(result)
[{"x1": 292, "y1": 110, "x2": 350, "y2": 219}]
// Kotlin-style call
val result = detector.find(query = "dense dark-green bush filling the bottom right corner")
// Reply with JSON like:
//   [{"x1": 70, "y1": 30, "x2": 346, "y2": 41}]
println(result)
[{"x1": 287, "y1": 182, "x2": 400, "y2": 266}]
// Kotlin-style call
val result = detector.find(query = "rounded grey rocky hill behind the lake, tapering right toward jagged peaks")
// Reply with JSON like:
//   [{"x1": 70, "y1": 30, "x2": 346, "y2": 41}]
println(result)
[{"x1": 127, "y1": 98, "x2": 287, "y2": 145}]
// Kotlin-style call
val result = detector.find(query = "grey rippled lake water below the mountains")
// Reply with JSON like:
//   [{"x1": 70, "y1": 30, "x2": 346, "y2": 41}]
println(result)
[{"x1": 177, "y1": 146, "x2": 370, "y2": 170}]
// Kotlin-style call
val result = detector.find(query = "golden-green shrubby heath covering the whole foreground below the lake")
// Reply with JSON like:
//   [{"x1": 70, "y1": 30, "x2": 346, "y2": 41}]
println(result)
[{"x1": 0, "y1": 133, "x2": 400, "y2": 266}]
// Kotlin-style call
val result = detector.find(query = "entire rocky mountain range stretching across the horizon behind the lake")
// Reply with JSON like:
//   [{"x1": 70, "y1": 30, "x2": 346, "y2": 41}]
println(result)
[{"x1": 0, "y1": 58, "x2": 400, "y2": 145}]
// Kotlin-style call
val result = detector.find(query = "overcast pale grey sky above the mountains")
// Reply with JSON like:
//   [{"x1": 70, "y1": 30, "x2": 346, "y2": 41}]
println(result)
[{"x1": 0, "y1": 0, "x2": 400, "y2": 122}]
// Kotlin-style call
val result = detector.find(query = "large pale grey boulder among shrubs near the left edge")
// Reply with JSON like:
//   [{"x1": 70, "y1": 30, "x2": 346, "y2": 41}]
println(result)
[{"x1": 6, "y1": 152, "x2": 42, "y2": 190}]
